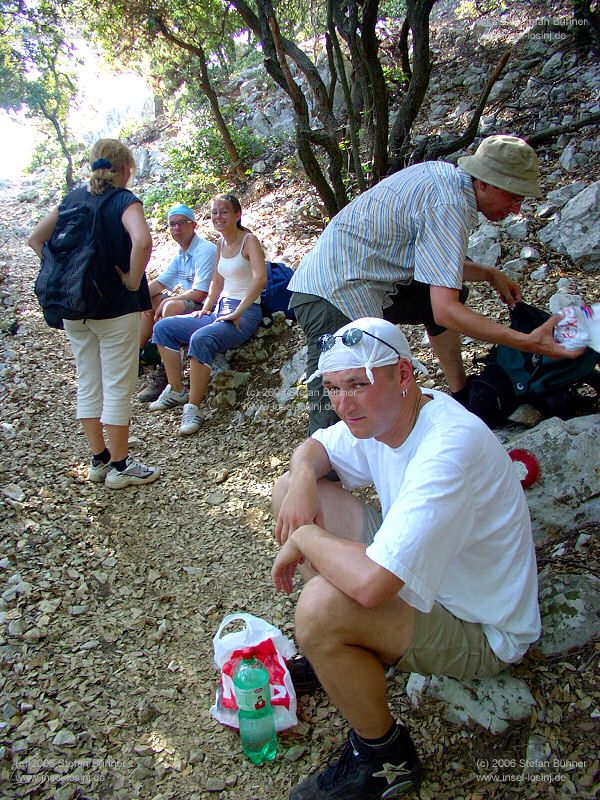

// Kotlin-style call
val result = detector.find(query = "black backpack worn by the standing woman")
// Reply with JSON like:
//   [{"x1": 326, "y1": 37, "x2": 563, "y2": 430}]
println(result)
[{"x1": 35, "y1": 189, "x2": 124, "y2": 329}]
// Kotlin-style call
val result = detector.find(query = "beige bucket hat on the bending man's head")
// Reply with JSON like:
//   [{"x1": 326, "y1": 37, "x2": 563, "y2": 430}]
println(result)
[{"x1": 458, "y1": 134, "x2": 542, "y2": 197}]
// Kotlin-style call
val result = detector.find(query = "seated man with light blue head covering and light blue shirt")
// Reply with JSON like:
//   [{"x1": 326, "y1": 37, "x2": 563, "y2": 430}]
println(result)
[{"x1": 137, "y1": 203, "x2": 217, "y2": 403}]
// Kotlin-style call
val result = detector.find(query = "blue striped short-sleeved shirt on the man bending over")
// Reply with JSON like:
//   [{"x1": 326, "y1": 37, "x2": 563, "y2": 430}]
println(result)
[{"x1": 288, "y1": 161, "x2": 477, "y2": 319}]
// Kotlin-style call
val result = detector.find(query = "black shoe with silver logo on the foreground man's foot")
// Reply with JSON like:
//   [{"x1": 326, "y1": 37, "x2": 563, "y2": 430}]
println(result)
[{"x1": 289, "y1": 725, "x2": 423, "y2": 800}]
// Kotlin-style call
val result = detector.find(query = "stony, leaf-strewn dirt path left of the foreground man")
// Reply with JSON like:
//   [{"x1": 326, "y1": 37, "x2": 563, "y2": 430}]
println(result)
[{"x1": 0, "y1": 177, "x2": 312, "y2": 800}]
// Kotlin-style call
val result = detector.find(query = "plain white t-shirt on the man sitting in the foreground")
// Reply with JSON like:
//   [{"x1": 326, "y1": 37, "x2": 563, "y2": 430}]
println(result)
[{"x1": 313, "y1": 390, "x2": 540, "y2": 663}]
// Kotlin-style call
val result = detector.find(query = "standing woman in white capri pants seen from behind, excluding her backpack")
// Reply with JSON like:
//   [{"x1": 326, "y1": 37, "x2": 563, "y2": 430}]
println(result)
[{"x1": 28, "y1": 139, "x2": 160, "y2": 489}]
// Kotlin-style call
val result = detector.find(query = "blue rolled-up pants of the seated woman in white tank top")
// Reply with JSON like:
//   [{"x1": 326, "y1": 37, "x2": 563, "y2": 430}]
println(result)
[{"x1": 152, "y1": 297, "x2": 262, "y2": 366}]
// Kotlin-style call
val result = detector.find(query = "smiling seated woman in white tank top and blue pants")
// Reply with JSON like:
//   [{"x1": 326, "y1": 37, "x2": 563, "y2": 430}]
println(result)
[{"x1": 150, "y1": 194, "x2": 267, "y2": 435}]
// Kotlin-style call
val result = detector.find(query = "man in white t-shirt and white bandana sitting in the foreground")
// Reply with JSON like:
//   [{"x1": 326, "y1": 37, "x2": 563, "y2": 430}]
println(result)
[{"x1": 272, "y1": 318, "x2": 540, "y2": 800}]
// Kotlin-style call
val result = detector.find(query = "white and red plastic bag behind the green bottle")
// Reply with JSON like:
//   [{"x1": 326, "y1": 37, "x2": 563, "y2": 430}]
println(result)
[{"x1": 210, "y1": 611, "x2": 298, "y2": 731}]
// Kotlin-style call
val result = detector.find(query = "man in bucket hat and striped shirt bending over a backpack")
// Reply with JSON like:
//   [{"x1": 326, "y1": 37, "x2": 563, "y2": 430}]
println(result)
[{"x1": 289, "y1": 135, "x2": 577, "y2": 432}]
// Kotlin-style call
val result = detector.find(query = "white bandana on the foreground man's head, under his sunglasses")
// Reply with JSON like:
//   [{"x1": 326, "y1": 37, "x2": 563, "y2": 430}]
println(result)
[{"x1": 307, "y1": 317, "x2": 427, "y2": 383}]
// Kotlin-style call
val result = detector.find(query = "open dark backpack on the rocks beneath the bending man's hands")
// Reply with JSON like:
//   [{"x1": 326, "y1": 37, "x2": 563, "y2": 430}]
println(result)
[{"x1": 467, "y1": 303, "x2": 600, "y2": 427}]
